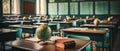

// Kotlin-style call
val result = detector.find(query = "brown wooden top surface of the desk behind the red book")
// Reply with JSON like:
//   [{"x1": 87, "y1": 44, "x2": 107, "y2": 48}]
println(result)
[{"x1": 62, "y1": 28, "x2": 108, "y2": 34}]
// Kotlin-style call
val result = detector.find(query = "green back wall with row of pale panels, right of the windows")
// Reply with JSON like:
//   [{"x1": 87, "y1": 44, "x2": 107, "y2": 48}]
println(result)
[{"x1": 47, "y1": 0, "x2": 120, "y2": 19}]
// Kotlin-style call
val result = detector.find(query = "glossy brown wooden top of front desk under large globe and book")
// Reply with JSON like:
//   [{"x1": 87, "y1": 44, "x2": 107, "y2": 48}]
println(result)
[{"x1": 7, "y1": 39, "x2": 91, "y2": 51}]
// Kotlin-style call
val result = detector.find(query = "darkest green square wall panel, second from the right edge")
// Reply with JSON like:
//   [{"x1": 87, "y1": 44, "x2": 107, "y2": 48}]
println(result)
[{"x1": 95, "y1": 1, "x2": 108, "y2": 14}]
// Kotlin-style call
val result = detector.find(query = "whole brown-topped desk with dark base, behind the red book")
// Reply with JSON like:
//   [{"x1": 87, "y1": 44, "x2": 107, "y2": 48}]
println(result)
[{"x1": 61, "y1": 28, "x2": 108, "y2": 51}]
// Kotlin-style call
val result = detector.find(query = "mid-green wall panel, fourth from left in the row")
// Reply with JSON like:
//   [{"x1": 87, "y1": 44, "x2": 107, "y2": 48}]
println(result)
[{"x1": 80, "y1": 2, "x2": 93, "y2": 15}]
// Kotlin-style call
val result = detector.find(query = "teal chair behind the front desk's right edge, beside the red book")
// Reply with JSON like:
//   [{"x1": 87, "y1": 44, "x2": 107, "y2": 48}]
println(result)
[{"x1": 67, "y1": 35, "x2": 91, "y2": 51}]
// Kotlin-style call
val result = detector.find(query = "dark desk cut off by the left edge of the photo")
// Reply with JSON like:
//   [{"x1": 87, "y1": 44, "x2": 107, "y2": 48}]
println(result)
[{"x1": 0, "y1": 28, "x2": 17, "y2": 51}]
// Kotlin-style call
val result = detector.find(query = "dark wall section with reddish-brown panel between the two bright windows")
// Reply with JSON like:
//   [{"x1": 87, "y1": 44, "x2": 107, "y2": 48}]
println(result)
[{"x1": 21, "y1": 0, "x2": 36, "y2": 16}]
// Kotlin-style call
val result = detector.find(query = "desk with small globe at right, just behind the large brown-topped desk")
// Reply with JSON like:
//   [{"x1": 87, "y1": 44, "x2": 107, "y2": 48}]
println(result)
[{"x1": 80, "y1": 24, "x2": 118, "y2": 47}]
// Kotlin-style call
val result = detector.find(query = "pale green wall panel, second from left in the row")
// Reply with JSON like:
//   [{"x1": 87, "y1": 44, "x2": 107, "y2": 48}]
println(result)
[{"x1": 59, "y1": 2, "x2": 68, "y2": 15}]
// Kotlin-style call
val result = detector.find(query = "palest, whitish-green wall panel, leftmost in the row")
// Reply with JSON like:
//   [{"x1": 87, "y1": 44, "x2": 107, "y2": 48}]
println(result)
[{"x1": 48, "y1": 3, "x2": 57, "y2": 15}]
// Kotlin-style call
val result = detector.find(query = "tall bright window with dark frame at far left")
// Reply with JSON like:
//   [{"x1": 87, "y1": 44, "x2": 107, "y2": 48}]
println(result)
[{"x1": 3, "y1": 0, "x2": 14, "y2": 14}]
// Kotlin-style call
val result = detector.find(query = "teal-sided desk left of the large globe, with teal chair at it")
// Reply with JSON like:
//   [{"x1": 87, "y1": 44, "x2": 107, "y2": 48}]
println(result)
[{"x1": 9, "y1": 25, "x2": 37, "y2": 38}]
